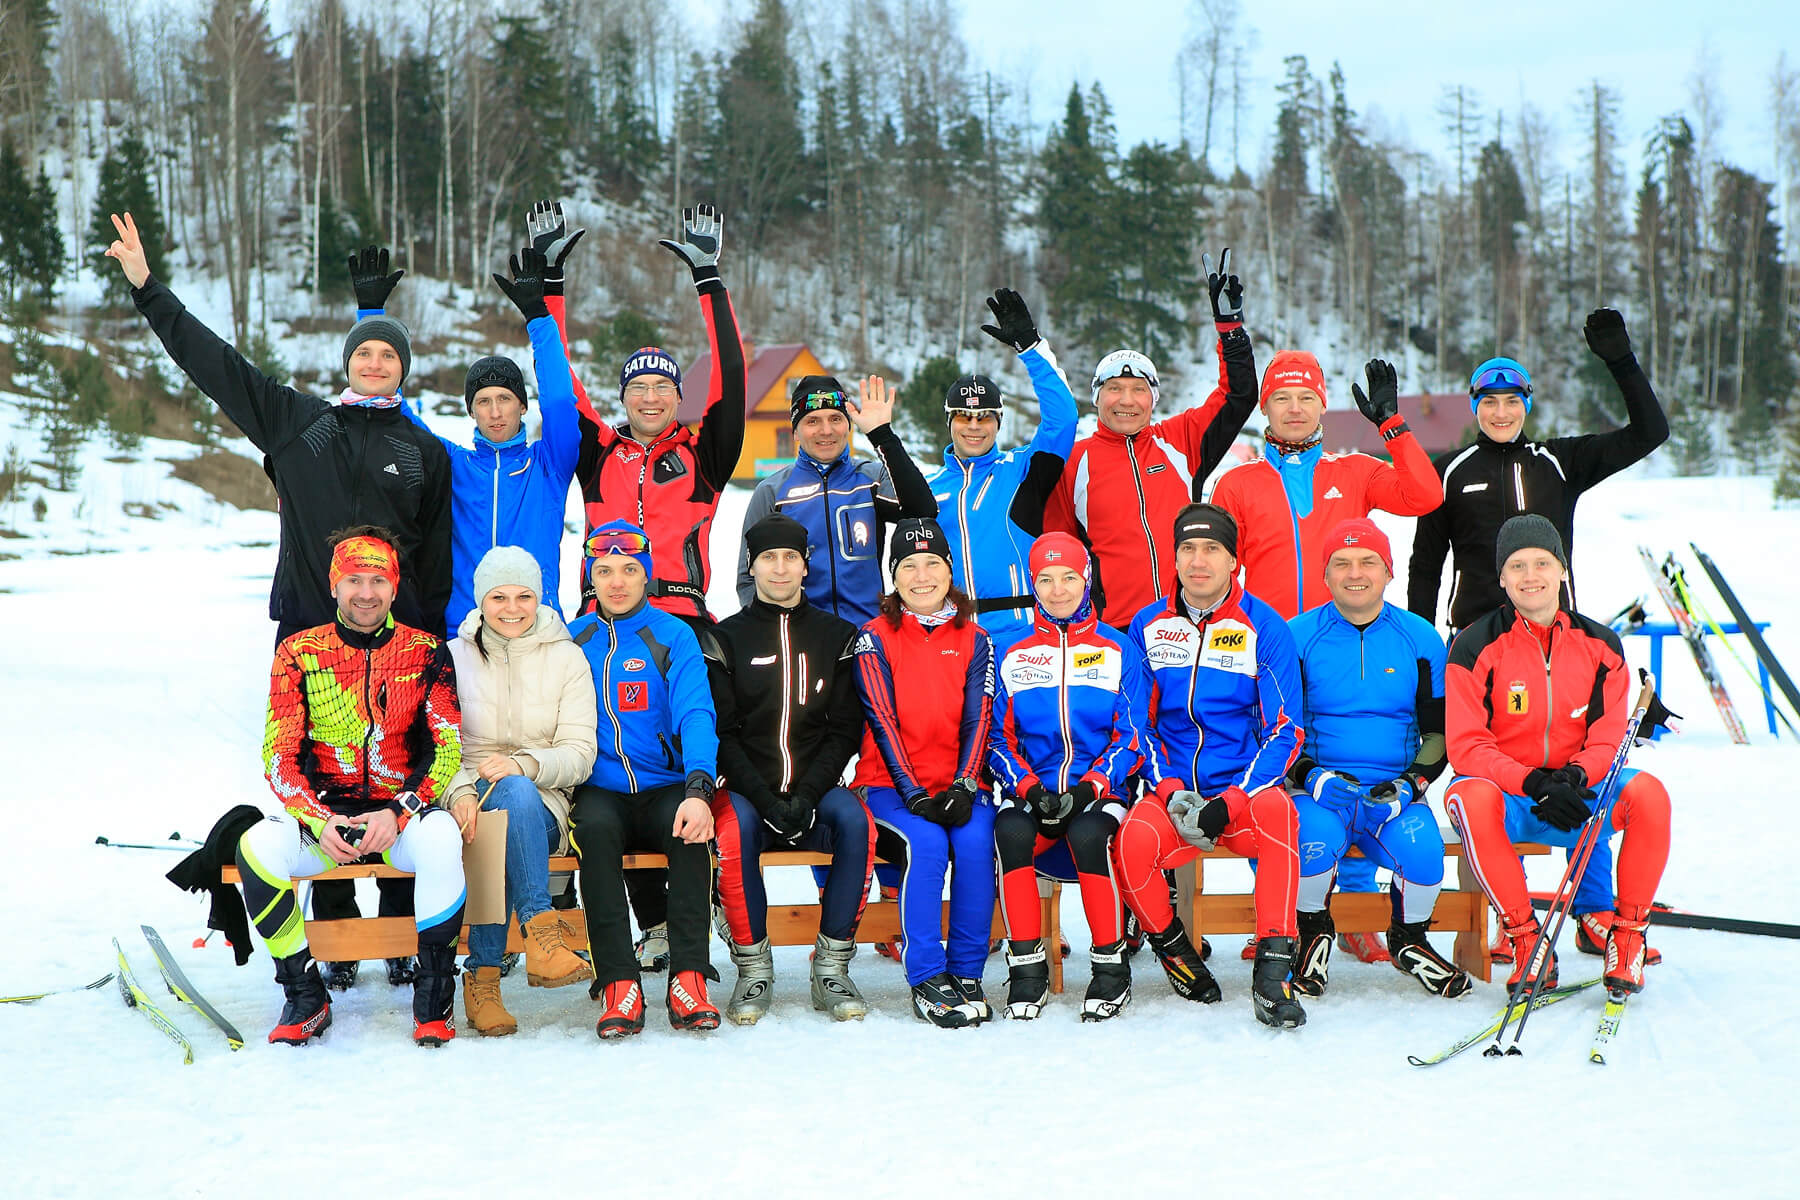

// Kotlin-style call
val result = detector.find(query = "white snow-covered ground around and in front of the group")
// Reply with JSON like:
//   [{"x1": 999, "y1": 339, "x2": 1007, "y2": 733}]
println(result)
[{"x1": 0, "y1": 464, "x2": 1800, "y2": 1196}]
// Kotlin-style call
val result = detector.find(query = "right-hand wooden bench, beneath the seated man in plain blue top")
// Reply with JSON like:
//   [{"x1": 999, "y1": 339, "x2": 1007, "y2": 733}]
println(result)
[{"x1": 1177, "y1": 831, "x2": 1550, "y2": 982}]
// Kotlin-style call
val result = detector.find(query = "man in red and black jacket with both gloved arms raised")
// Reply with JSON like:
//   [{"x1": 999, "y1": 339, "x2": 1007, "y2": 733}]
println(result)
[{"x1": 527, "y1": 205, "x2": 745, "y2": 622}]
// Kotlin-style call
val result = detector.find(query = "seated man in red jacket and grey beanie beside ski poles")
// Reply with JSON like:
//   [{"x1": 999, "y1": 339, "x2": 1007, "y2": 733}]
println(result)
[{"x1": 1444, "y1": 513, "x2": 1669, "y2": 993}]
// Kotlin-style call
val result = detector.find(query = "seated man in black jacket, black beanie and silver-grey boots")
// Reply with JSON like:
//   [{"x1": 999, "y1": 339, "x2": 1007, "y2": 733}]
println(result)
[{"x1": 702, "y1": 513, "x2": 875, "y2": 1025}]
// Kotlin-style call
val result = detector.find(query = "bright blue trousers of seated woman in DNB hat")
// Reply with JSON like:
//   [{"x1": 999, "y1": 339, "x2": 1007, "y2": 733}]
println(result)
[{"x1": 869, "y1": 788, "x2": 995, "y2": 986}]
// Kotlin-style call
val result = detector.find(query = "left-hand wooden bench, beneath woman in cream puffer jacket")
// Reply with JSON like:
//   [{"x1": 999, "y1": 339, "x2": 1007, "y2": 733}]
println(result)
[{"x1": 223, "y1": 851, "x2": 1065, "y2": 991}]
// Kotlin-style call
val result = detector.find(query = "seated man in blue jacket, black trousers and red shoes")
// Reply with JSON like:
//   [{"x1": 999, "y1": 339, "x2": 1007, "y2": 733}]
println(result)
[{"x1": 569, "y1": 520, "x2": 718, "y2": 1038}]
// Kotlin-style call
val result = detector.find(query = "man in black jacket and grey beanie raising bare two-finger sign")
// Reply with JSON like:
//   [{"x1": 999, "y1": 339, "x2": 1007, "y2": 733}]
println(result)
[{"x1": 106, "y1": 212, "x2": 450, "y2": 642}]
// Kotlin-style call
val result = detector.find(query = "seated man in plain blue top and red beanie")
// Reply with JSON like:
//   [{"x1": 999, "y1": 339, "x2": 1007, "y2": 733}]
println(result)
[{"x1": 1289, "y1": 518, "x2": 1469, "y2": 997}]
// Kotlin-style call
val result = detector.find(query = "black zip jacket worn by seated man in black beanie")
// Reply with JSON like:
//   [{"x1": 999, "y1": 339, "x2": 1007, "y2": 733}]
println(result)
[{"x1": 706, "y1": 597, "x2": 862, "y2": 813}]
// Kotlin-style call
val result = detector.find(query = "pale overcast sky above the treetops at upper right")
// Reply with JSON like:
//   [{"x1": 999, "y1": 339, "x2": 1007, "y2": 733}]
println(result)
[{"x1": 961, "y1": 0, "x2": 1800, "y2": 178}]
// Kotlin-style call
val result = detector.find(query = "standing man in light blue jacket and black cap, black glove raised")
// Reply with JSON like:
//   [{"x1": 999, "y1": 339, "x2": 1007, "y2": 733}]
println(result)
[{"x1": 931, "y1": 288, "x2": 1076, "y2": 648}]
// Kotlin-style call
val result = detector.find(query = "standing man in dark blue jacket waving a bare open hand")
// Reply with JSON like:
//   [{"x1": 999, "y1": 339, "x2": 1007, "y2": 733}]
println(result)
[{"x1": 738, "y1": 374, "x2": 938, "y2": 626}]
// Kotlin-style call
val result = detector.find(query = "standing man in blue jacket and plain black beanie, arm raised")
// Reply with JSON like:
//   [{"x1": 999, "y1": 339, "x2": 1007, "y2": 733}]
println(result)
[{"x1": 351, "y1": 246, "x2": 581, "y2": 637}]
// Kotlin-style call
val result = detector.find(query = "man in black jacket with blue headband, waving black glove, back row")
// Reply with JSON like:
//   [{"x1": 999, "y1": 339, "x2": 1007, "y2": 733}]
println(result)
[{"x1": 1406, "y1": 308, "x2": 1669, "y2": 630}]
